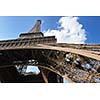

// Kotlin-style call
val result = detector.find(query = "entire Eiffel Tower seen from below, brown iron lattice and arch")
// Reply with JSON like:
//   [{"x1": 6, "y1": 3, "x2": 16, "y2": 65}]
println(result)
[{"x1": 0, "y1": 20, "x2": 100, "y2": 83}]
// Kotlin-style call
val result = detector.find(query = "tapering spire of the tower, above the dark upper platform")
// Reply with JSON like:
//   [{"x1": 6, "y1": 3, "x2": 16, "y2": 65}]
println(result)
[{"x1": 28, "y1": 20, "x2": 41, "y2": 33}]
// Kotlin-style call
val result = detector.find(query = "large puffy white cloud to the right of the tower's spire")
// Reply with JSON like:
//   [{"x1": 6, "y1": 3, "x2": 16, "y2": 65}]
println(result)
[{"x1": 44, "y1": 17, "x2": 87, "y2": 43}]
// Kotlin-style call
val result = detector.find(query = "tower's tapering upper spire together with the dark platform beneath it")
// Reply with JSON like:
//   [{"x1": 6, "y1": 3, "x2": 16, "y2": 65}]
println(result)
[{"x1": 19, "y1": 20, "x2": 44, "y2": 38}]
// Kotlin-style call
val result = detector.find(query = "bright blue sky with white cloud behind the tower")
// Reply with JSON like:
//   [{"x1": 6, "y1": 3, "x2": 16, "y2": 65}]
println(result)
[{"x1": 0, "y1": 16, "x2": 100, "y2": 43}]
